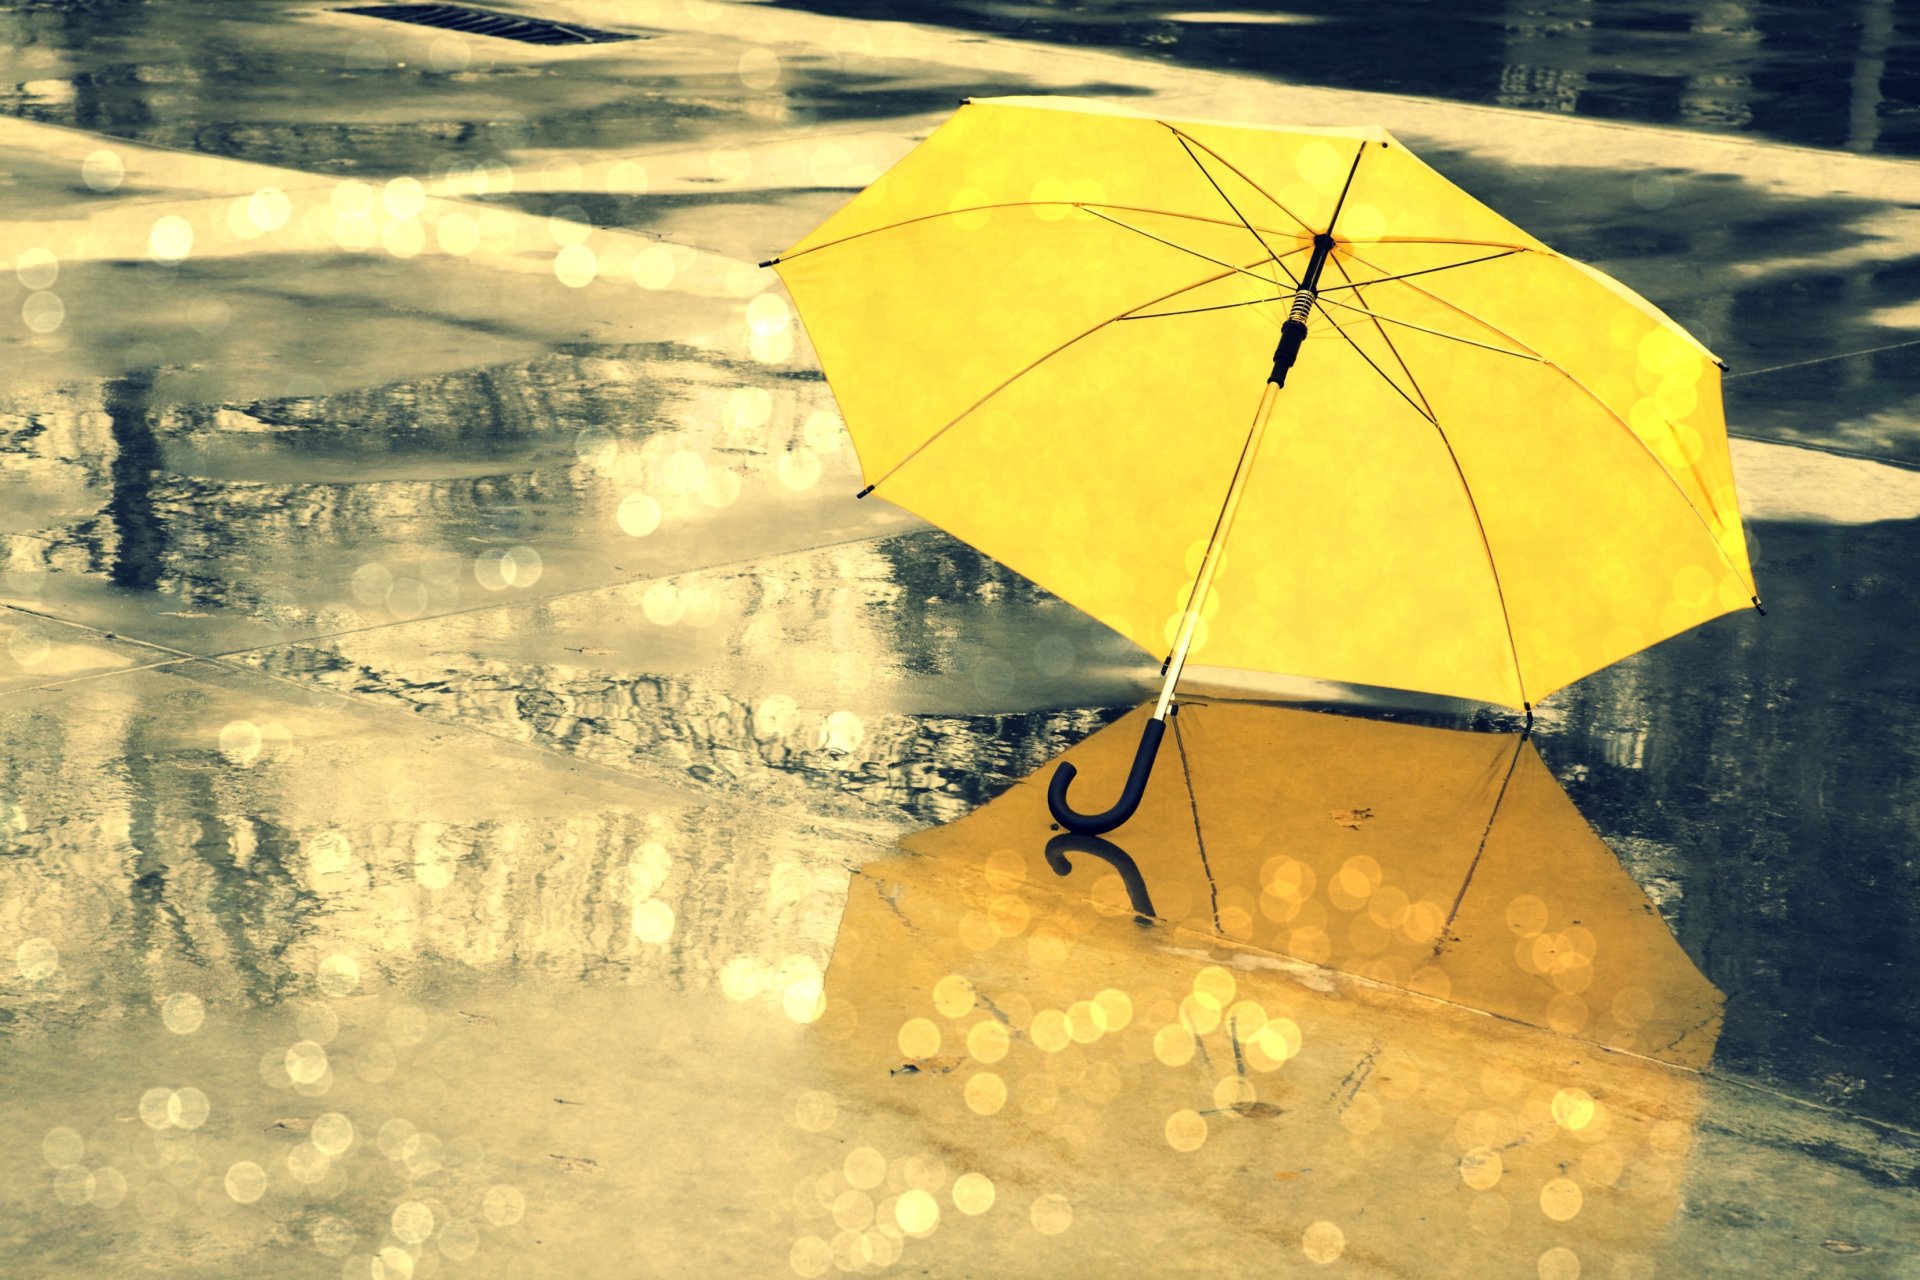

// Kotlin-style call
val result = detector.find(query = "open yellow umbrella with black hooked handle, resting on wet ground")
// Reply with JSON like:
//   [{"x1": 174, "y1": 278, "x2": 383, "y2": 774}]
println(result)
[{"x1": 770, "y1": 98, "x2": 1759, "y2": 831}]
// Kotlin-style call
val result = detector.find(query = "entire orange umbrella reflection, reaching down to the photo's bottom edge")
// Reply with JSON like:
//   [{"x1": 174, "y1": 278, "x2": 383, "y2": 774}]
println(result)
[{"x1": 801, "y1": 702, "x2": 1720, "y2": 1278}]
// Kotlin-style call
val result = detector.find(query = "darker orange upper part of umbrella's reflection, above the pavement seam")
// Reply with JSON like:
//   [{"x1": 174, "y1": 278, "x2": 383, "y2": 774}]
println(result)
[{"x1": 906, "y1": 702, "x2": 1722, "y2": 1067}]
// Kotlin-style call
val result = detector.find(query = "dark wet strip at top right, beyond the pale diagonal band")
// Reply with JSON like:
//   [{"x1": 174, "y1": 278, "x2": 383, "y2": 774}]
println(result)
[{"x1": 781, "y1": 0, "x2": 1920, "y2": 155}]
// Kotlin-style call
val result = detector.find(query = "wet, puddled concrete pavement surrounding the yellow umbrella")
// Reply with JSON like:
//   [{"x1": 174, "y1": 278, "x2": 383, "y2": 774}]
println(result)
[{"x1": 0, "y1": 4, "x2": 1920, "y2": 1276}]
